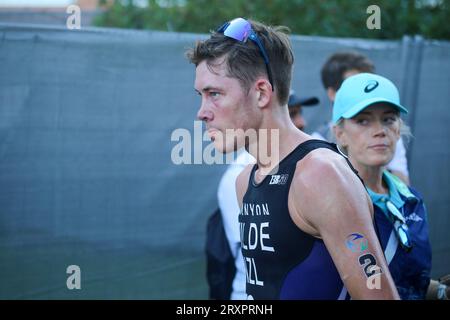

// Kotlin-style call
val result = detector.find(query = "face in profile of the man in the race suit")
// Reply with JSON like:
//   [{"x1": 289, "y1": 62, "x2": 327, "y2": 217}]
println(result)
[{"x1": 194, "y1": 60, "x2": 261, "y2": 153}]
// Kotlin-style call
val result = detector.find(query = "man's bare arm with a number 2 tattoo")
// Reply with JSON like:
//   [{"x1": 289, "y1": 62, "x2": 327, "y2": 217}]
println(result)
[{"x1": 289, "y1": 149, "x2": 399, "y2": 299}]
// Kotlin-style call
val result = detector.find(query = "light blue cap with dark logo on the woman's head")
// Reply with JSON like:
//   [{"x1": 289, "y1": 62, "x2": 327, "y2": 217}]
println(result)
[{"x1": 333, "y1": 73, "x2": 408, "y2": 124}]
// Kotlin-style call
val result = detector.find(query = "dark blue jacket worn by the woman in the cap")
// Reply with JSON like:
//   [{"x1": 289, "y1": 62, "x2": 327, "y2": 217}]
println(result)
[{"x1": 369, "y1": 171, "x2": 431, "y2": 300}]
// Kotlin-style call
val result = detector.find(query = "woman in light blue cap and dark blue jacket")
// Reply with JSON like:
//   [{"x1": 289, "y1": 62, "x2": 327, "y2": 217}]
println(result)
[{"x1": 333, "y1": 73, "x2": 448, "y2": 299}]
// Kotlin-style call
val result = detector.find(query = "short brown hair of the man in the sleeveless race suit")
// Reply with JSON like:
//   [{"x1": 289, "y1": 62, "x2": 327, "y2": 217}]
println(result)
[{"x1": 186, "y1": 20, "x2": 294, "y2": 105}]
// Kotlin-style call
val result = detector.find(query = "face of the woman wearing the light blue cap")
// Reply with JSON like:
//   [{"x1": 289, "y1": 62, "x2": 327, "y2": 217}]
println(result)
[{"x1": 335, "y1": 103, "x2": 400, "y2": 167}]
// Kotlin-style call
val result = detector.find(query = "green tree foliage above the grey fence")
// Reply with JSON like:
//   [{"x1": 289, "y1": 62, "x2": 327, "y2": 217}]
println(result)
[{"x1": 96, "y1": 0, "x2": 450, "y2": 39}]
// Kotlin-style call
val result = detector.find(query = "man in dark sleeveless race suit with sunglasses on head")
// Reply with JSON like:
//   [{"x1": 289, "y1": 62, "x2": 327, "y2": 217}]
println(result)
[{"x1": 187, "y1": 18, "x2": 398, "y2": 299}]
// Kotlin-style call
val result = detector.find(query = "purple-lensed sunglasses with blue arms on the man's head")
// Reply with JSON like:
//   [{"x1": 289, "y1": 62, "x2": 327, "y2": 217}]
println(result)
[{"x1": 217, "y1": 18, "x2": 274, "y2": 91}]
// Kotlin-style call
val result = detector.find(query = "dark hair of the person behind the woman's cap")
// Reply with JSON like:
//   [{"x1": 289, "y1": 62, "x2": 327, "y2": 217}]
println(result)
[{"x1": 321, "y1": 51, "x2": 375, "y2": 91}]
